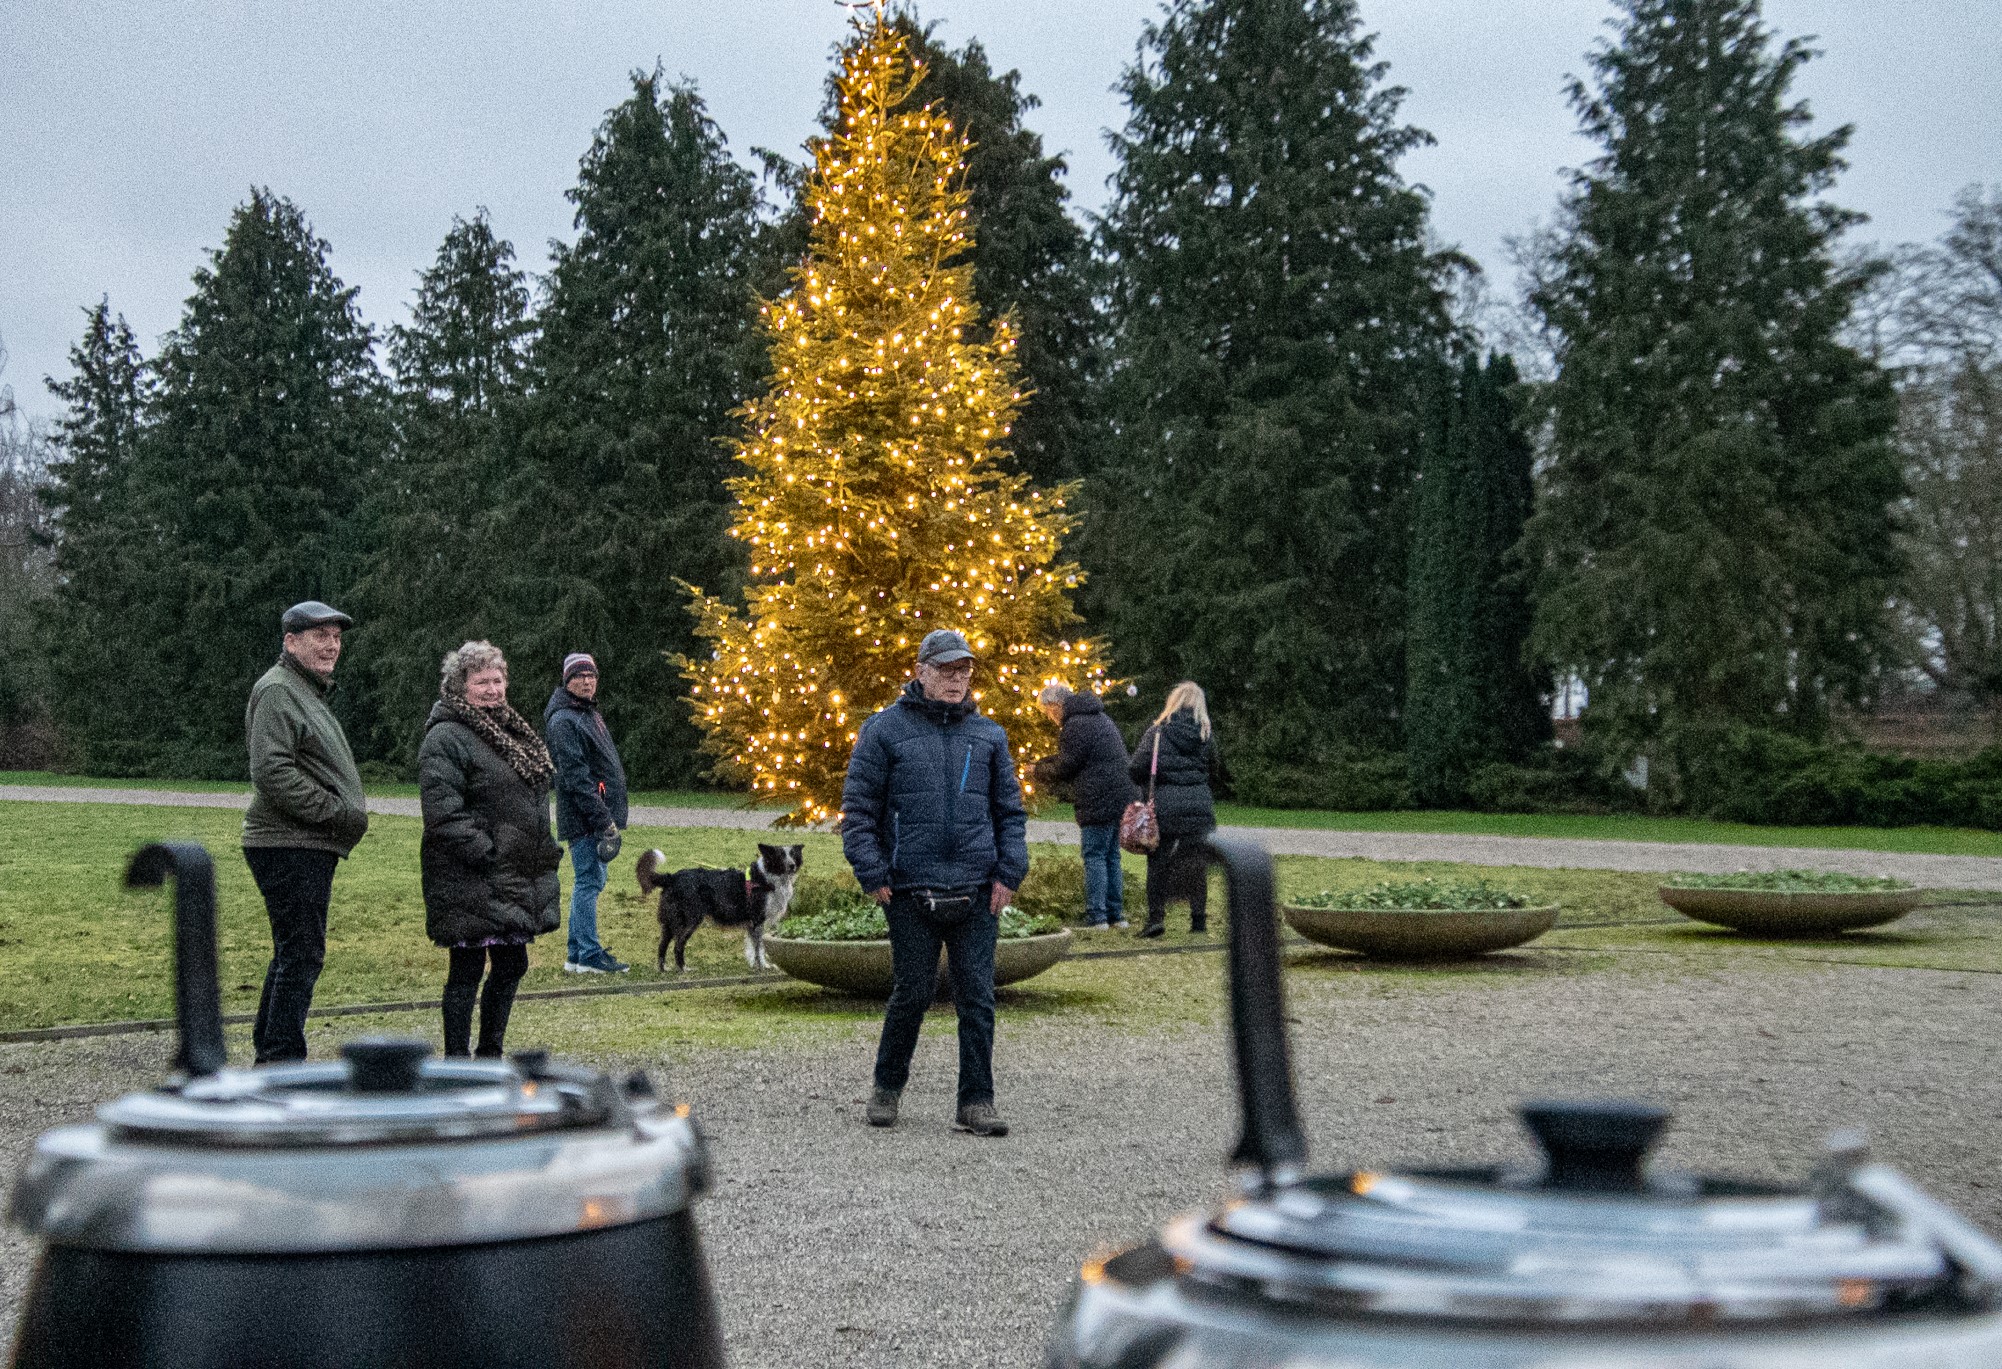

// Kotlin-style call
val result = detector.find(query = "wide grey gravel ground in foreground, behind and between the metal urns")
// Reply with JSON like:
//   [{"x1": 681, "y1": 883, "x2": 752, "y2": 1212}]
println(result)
[{"x1": 0, "y1": 953, "x2": 2002, "y2": 1367}]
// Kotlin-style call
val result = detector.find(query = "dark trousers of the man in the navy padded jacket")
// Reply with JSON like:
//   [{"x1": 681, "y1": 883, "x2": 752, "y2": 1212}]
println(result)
[{"x1": 875, "y1": 885, "x2": 1001, "y2": 1107}]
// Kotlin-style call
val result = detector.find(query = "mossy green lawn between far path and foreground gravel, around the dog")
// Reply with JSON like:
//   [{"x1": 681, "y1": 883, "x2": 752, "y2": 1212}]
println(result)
[{"x1": 0, "y1": 803, "x2": 1697, "y2": 1031}]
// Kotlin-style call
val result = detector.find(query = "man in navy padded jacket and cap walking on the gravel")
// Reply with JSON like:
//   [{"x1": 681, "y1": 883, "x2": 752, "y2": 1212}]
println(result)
[{"x1": 841, "y1": 628, "x2": 1029, "y2": 1137}]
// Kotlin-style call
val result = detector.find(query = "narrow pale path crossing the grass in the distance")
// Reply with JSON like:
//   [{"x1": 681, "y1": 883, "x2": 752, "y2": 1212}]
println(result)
[{"x1": 0, "y1": 785, "x2": 2002, "y2": 889}]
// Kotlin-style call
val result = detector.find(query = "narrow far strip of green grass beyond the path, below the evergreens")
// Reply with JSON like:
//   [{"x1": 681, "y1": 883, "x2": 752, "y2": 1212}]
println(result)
[{"x1": 0, "y1": 771, "x2": 2002, "y2": 857}]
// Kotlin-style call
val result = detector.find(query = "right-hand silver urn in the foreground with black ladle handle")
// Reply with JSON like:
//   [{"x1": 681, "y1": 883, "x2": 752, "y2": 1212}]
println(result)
[{"x1": 1047, "y1": 841, "x2": 2002, "y2": 1369}]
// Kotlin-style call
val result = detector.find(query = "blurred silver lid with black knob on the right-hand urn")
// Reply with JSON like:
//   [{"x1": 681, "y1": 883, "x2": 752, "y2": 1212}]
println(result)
[{"x1": 1163, "y1": 1103, "x2": 2002, "y2": 1325}]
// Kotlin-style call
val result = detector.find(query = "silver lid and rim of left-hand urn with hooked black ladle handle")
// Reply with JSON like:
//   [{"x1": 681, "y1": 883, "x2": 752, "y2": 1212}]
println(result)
[{"x1": 12, "y1": 845, "x2": 709, "y2": 1253}]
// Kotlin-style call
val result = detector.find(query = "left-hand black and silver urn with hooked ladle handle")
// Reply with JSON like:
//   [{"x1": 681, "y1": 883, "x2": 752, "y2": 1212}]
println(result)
[{"x1": 12, "y1": 845, "x2": 723, "y2": 1369}]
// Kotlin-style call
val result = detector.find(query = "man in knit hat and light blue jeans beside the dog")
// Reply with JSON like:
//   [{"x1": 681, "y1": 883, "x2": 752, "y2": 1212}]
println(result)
[{"x1": 543, "y1": 650, "x2": 633, "y2": 975}]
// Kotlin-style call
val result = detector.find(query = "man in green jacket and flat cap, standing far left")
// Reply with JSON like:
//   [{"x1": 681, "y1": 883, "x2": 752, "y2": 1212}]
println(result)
[{"x1": 244, "y1": 598, "x2": 368, "y2": 1065}]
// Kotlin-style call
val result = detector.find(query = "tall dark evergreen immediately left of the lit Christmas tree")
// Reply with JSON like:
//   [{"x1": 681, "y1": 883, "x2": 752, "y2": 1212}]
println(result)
[{"x1": 503, "y1": 72, "x2": 761, "y2": 785}]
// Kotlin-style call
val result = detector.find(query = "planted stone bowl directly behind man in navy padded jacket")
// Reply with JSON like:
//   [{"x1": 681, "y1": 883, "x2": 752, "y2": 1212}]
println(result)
[{"x1": 765, "y1": 879, "x2": 1071, "y2": 999}]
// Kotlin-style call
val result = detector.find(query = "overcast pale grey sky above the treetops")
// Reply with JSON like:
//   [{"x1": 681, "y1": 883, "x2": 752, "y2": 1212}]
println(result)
[{"x1": 0, "y1": 0, "x2": 2002, "y2": 416}]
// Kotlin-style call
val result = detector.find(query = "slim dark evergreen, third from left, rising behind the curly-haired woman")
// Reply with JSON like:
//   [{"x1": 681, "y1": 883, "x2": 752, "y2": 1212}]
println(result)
[{"x1": 356, "y1": 210, "x2": 535, "y2": 765}]
